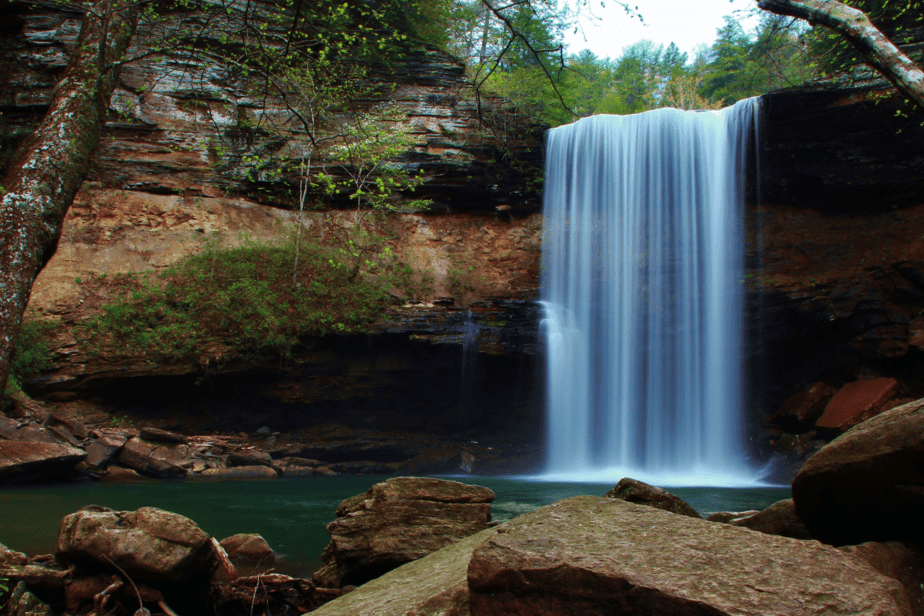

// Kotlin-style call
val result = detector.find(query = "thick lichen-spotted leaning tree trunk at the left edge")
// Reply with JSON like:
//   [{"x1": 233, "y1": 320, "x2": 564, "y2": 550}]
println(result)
[{"x1": 0, "y1": 0, "x2": 138, "y2": 393}]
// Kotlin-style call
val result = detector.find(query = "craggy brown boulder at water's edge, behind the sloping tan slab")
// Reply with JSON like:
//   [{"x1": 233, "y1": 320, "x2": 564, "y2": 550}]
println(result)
[{"x1": 314, "y1": 477, "x2": 494, "y2": 588}]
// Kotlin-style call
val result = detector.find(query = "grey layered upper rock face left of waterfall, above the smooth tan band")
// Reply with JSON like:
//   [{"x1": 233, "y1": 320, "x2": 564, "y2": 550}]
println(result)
[{"x1": 0, "y1": 3, "x2": 544, "y2": 211}]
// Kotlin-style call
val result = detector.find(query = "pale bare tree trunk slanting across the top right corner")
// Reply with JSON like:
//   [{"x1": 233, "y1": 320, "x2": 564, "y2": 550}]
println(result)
[{"x1": 757, "y1": 0, "x2": 924, "y2": 108}]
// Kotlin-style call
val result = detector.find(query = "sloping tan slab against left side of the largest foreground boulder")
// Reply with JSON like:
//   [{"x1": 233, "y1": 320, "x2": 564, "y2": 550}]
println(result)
[{"x1": 312, "y1": 528, "x2": 498, "y2": 616}]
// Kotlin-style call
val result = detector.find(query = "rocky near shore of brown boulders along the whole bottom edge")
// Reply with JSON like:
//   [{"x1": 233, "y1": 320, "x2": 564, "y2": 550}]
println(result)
[{"x1": 0, "y1": 399, "x2": 924, "y2": 616}]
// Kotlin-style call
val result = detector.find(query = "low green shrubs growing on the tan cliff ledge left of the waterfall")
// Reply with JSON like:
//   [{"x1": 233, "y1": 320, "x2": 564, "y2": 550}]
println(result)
[{"x1": 80, "y1": 233, "x2": 409, "y2": 361}]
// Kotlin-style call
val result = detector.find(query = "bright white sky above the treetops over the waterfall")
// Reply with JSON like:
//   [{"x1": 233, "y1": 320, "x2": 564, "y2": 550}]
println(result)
[{"x1": 565, "y1": 0, "x2": 757, "y2": 60}]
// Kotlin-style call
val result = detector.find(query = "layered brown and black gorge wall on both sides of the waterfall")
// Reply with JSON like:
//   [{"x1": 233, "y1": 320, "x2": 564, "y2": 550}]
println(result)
[{"x1": 0, "y1": 3, "x2": 924, "y2": 472}]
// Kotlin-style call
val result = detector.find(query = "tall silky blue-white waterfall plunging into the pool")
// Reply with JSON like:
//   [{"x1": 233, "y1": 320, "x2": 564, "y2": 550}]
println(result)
[{"x1": 542, "y1": 100, "x2": 757, "y2": 486}]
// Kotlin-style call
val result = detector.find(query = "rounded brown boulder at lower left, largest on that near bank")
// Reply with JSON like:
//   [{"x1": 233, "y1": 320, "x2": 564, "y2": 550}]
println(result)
[{"x1": 57, "y1": 506, "x2": 217, "y2": 582}]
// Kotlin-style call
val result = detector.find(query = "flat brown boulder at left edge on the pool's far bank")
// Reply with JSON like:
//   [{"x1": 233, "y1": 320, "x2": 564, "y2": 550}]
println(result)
[{"x1": 0, "y1": 441, "x2": 87, "y2": 483}]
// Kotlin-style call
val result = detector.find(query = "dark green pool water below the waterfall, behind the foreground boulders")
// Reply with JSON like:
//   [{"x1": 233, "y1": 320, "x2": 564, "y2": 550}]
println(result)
[{"x1": 0, "y1": 476, "x2": 790, "y2": 577}]
